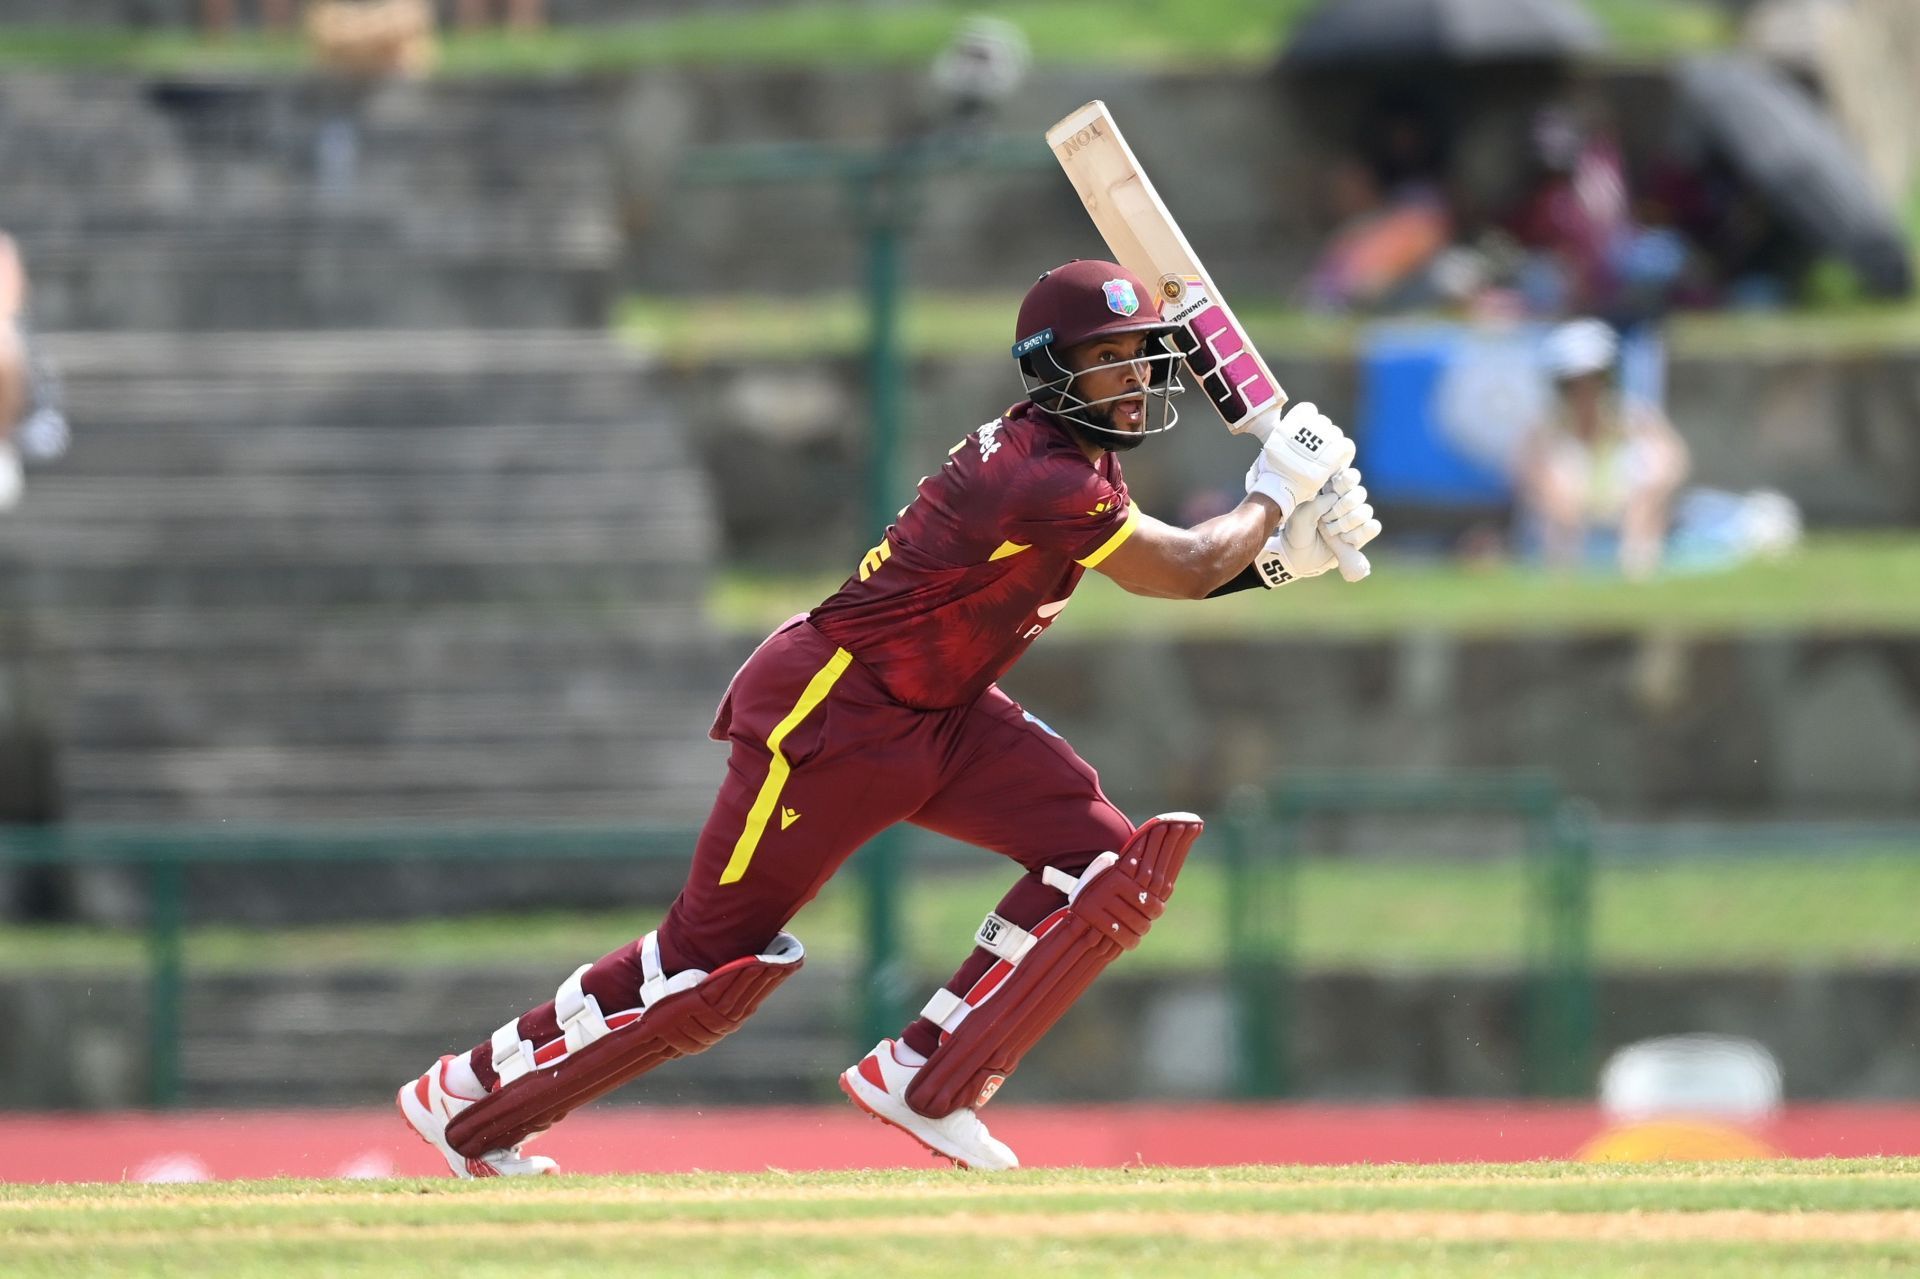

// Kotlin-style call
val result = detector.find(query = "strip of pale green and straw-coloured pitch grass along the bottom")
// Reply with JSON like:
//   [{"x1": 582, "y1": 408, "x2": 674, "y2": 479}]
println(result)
[{"x1": 0, "y1": 1158, "x2": 1920, "y2": 1279}]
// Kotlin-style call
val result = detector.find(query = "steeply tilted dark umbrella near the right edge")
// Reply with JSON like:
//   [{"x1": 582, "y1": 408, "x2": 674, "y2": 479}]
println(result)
[{"x1": 1678, "y1": 54, "x2": 1912, "y2": 296}]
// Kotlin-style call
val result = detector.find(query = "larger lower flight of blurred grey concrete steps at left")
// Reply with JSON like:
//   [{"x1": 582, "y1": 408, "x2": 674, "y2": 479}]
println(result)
[{"x1": 0, "y1": 332, "x2": 725, "y2": 825}]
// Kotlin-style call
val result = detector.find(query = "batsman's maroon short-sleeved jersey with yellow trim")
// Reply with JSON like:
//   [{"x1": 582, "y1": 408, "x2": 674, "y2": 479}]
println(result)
[{"x1": 808, "y1": 401, "x2": 1139, "y2": 711}]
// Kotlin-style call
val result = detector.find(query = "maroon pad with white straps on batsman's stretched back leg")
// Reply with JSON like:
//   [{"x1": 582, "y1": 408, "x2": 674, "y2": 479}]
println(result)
[{"x1": 447, "y1": 933, "x2": 806, "y2": 1156}]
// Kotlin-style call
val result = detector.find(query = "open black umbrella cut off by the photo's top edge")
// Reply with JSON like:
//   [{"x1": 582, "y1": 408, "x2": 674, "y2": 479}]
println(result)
[{"x1": 1281, "y1": 0, "x2": 1607, "y2": 67}]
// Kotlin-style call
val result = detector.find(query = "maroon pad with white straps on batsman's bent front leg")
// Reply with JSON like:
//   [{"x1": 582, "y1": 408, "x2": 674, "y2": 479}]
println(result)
[{"x1": 906, "y1": 812, "x2": 1202, "y2": 1120}]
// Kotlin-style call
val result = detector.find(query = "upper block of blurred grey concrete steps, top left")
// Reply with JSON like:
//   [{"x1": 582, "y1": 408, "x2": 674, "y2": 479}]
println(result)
[{"x1": 0, "y1": 75, "x2": 622, "y2": 330}]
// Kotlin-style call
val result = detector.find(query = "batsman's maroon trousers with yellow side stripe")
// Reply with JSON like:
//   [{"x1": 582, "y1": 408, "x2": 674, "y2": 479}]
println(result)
[{"x1": 472, "y1": 618, "x2": 1133, "y2": 1087}]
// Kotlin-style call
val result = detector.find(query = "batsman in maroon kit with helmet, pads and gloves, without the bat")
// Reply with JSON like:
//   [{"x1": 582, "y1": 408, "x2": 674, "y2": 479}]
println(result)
[{"x1": 397, "y1": 261, "x2": 1380, "y2": 1177}]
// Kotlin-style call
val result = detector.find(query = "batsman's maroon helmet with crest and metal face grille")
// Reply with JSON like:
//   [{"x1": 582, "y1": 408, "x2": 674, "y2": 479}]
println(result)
[{"x1": 1014, "y1": 257, "x2": 1187, "y2": 451}]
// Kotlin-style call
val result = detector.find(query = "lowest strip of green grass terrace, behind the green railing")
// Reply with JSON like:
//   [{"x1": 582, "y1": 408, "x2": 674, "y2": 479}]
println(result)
[{"x1": 0, "y1": 845, "x2": 1920, "y2": 972}]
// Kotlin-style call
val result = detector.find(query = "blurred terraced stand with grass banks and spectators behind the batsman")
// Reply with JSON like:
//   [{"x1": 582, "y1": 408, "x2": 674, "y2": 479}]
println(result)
[{"x1": 0, "y1": 0, "x2": 1920, "y2": 1152}]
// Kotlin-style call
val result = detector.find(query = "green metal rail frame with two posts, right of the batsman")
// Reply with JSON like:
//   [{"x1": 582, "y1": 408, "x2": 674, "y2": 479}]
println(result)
[{"x1": 1223, "y1": 770, "x2": 1594, "y2": 1097}]
